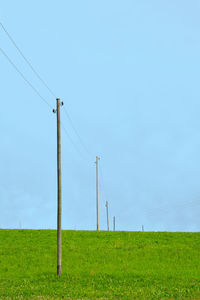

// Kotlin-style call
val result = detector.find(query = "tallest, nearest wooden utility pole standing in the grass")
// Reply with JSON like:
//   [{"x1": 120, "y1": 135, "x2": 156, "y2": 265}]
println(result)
[{"x1": 53, "y1": 98, "x2": 64, "y2": 276}]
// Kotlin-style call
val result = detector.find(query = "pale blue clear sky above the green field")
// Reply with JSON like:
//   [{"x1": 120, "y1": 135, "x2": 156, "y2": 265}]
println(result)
[{"x1": 0, "y1": 0, "x2": 200, "y2": 231}]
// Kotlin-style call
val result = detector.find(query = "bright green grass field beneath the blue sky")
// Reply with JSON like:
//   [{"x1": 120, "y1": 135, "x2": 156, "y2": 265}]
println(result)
[{"x1": 0, "y1": 229, "x2": 200, "y2": 299}]
